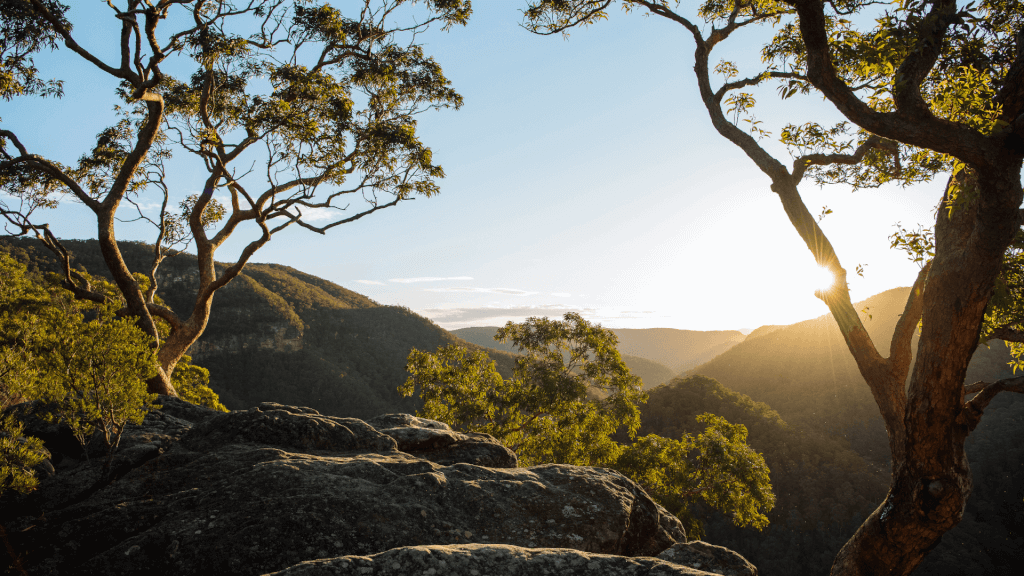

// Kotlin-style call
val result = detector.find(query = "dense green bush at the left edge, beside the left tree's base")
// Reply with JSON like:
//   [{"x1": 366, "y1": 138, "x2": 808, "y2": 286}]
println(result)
[{"x1": 0, "y1": 254, "x2": 160, "y2": 457}]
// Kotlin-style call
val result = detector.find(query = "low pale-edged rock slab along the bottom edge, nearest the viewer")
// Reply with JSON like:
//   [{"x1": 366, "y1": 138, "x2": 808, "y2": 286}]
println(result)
[{"x1": 267, "y1": 544, "x2": 729, "y2": 576}]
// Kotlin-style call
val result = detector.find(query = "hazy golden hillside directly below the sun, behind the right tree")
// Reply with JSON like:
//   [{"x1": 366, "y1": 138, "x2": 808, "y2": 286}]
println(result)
[{"x1": 688, "y1": 288, "x2": 1012, "y2": 462}]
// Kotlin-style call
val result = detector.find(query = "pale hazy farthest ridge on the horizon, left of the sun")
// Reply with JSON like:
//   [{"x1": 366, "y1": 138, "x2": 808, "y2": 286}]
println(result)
[{"x1": 612, "y1": 328, "x2": 745, "y2": 374}]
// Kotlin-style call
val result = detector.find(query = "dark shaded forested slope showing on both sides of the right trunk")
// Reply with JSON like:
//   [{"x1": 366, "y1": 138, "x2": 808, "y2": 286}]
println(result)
[{"x1": 640, "y1": 376, "x2": 1024, "y2": 576}]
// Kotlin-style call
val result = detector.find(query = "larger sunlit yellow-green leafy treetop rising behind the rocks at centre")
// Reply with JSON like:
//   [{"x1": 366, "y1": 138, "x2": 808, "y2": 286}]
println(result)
[{"x1": 400, "y1": 313, "x2": 646, "y2": 465}]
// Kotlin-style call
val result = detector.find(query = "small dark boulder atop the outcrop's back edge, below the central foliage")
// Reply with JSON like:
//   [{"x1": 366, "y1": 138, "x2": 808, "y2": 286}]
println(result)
[{"x1": 367, "y1": 414, "x2": 519, "y2": 468}]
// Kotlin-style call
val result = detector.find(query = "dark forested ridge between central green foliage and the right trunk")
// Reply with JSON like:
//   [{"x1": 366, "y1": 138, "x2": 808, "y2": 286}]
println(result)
[{"x1": 640, "y1": 376, "x2": 888, "y2": 576}]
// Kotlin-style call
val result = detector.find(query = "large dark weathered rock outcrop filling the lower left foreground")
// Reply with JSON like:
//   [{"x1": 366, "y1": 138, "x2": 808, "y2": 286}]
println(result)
[{"x1": 0, "y1": 398, "x2": 753, "y2": 575}]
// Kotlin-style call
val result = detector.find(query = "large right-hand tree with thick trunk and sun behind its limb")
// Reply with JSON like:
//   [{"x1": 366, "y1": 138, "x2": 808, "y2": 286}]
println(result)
[{"x1": 524, "y1": 0, "x2": 1024, "y2": 575}]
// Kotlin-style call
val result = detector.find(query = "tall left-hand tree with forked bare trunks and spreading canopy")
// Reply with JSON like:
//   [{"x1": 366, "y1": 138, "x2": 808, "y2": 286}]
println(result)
[{"x1": 0, "y1": 0, "x2": 471, "y2": 395}]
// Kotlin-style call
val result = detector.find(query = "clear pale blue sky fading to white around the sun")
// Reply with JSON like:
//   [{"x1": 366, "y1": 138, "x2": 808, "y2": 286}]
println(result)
[{"x1": 0, "y1": 0, "x2": 941, "y2": 330}]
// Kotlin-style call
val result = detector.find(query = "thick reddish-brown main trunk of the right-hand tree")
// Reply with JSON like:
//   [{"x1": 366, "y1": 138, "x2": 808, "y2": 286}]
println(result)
[{"x1": 831, "y1": 165, "x2": 1022, "y2": 576}]
